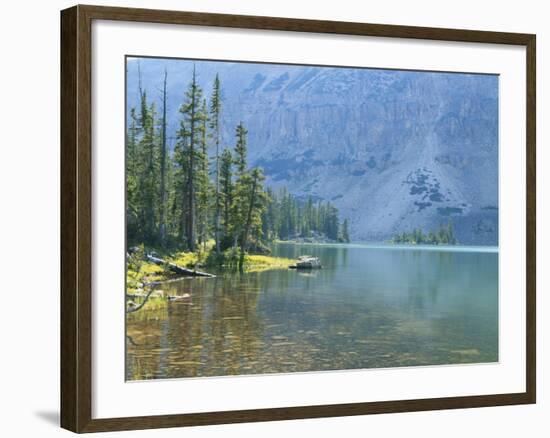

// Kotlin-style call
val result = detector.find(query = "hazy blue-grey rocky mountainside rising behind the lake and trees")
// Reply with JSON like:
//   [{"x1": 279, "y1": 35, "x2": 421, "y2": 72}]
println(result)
[{"x1": 128, "y1": 60, "x2": 498, "y2": 245}]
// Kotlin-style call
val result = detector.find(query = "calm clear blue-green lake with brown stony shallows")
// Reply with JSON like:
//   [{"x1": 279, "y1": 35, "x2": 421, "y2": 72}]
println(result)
[{"x1": 126, "y1": 243, "x2": 498, "y2": 380}]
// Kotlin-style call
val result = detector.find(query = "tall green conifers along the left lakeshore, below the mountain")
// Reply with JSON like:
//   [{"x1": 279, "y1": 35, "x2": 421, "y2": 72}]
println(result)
[{"x1": 126, "y1": 66, "x2": 349, "y2": 268}]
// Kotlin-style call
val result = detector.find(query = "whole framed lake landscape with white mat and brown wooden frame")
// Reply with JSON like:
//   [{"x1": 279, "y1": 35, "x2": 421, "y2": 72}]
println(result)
[{"x1": 61, "y1": 6, "x2": 536, "y2": 432}]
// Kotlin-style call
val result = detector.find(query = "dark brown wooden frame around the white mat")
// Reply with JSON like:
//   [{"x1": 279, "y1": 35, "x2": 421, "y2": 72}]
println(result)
[{"x1": 61, "y1": 5, "x2": 536, "y2": 433}]
